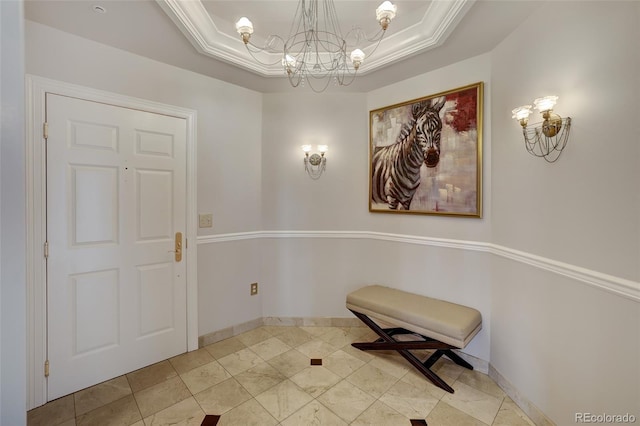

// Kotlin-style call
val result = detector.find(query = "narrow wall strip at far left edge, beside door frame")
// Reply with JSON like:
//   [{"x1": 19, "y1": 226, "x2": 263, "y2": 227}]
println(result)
[{"x1": 0, "y1": 1, "x2": 27, "y2": 426}]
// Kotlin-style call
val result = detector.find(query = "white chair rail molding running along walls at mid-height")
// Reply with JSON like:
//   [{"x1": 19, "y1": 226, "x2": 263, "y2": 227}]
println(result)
[{"x1": 197, "y1": 231, "x2": 640, "y2": 302}]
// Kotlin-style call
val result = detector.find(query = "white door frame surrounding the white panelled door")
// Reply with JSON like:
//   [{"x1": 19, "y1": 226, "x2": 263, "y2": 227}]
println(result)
[{"x1": 25, "y1": 74, "x2": 198, "y2": 409}]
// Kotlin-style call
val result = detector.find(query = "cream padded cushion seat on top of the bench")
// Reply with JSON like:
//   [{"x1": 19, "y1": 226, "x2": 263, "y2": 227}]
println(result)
[{"x1": 347, "y1": 285, "x2": 482, "y2": 348}]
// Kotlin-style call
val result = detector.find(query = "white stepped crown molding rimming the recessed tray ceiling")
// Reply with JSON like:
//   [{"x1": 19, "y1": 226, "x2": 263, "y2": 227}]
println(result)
[{"x1": 156, "y1": 0, "x2": 476, "y2": 77}]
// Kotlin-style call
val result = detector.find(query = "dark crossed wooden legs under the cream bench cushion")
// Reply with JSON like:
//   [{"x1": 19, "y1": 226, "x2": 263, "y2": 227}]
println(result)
[{"x1": 351, "y1": 311, "x2": 473, "y2": 393}]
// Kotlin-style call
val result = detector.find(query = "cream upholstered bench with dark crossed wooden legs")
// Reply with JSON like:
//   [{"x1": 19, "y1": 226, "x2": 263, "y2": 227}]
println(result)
[{"x1": 347, "y1": 285, "x2": 482, "y2": 393}]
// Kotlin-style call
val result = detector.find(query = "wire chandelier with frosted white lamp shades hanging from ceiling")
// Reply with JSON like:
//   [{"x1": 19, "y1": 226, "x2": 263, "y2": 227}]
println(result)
[{"x1": 236, "y1": 0, "x2": 396, "y2": 92}]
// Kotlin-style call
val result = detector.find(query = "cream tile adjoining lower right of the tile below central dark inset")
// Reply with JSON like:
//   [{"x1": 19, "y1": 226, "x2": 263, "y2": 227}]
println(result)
[{"x1": 317, "y1": 380, "x2": 375, "y2": 423}]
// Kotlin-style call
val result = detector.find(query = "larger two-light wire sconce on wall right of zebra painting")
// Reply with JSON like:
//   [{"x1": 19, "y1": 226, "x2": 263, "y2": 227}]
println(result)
[{"x1": 511, "y1": 96, "x2": 571, "y2": 163}]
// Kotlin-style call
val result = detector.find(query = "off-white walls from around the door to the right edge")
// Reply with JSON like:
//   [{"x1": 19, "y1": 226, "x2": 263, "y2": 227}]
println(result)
[{"x1": 23, "y1": 1, "x2": 640, "y2": 424}]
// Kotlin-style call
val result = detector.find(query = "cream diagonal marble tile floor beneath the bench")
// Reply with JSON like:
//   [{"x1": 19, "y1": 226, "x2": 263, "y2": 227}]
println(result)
[{"x1": 27, "y1": 326, "x2": 533, "y2": 426}]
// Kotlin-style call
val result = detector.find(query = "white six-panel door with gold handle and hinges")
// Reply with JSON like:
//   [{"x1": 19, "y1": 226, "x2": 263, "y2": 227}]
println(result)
[{"x1": 46, "y1": 93, "x2": 187, "y2": 400}]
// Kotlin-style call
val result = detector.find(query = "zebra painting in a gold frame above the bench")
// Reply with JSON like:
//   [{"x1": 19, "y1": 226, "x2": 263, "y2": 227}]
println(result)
[{"x1": 369, "y1": 82, "x2": 484, "y2": 218}]
